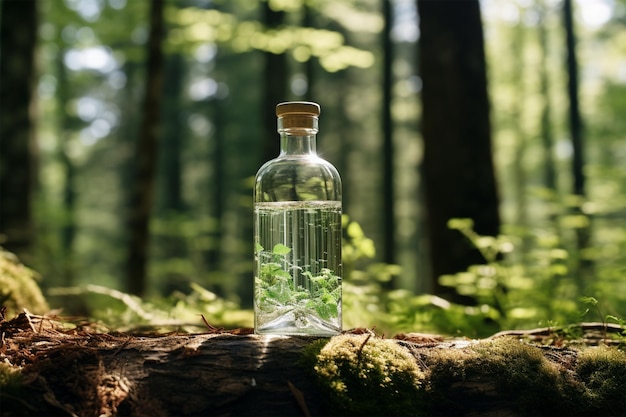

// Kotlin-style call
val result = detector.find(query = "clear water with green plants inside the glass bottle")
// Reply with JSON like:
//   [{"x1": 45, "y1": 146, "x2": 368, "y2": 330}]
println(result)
[{"x1": 254, "y1": 201, "x2": 341, "y2": 336}]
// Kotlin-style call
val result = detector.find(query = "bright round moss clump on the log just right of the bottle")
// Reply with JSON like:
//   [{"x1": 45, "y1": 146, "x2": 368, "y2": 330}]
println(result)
[{"x1": 314, "y1": 335, "x2": 424, "y2": 416}]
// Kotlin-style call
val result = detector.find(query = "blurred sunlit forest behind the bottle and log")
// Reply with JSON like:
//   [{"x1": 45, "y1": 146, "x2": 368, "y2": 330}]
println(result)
[{"x1": 0, "y1": 0, "x2": 626, "y2": 336}]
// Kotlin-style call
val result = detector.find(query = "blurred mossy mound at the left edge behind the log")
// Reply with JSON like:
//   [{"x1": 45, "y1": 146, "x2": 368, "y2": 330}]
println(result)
[{"x1": 0, "y1": 248, "x2": 48, "y2": 318}]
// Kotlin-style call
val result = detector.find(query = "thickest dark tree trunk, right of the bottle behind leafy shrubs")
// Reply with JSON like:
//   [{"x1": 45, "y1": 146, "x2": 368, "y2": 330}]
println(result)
[{"x1": 417, "y1": 0, "x2": 500, "y2": 295}]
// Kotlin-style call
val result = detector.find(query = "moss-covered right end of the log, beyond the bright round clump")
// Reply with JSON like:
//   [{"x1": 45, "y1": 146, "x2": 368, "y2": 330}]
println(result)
[{"x1": 426, "y1": 338, "x2": 626, "y2": 416}]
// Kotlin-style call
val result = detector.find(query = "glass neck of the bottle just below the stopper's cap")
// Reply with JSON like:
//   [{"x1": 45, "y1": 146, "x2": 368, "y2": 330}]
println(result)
[{"x1": 278, "y1": 117, "x2": 317, "y2": 156}]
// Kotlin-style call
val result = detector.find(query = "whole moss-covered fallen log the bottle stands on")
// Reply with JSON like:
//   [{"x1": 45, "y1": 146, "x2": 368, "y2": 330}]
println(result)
[{"x1": 0, "y1": 315, "x2": 626, "y2": 417}]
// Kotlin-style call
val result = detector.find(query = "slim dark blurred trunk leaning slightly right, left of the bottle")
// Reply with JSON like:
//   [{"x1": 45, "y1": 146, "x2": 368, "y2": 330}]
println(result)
[{"x1": 126, "y1": 0, "x2": 164, "y2": 296}]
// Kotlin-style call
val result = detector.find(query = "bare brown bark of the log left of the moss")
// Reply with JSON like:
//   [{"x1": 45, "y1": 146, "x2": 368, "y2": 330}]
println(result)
[{"x1": 2, "y1": 328, "x2": 328, "y2": 417}]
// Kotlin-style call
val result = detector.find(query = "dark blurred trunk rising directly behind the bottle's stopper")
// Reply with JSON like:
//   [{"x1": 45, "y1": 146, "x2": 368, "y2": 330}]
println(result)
[{"x1": 261, "y1": 1, "x2": 287, "y2": 161}]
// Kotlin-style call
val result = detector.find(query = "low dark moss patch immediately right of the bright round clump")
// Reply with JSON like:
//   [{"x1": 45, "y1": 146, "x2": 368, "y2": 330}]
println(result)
[{"x1": 427, "y1": 339, "x2": 567, "y2": 415}]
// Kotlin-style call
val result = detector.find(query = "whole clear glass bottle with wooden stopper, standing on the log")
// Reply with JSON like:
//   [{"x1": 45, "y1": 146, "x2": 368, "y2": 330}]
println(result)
[{"x1": 254, "y1": 102, "x2": 342, "y2": 336}]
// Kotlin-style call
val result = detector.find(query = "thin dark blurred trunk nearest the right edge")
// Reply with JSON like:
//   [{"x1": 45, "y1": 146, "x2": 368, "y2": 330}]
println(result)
[{"x1": 563, "y1": 0, "x2": 593, "y2": 282}]
